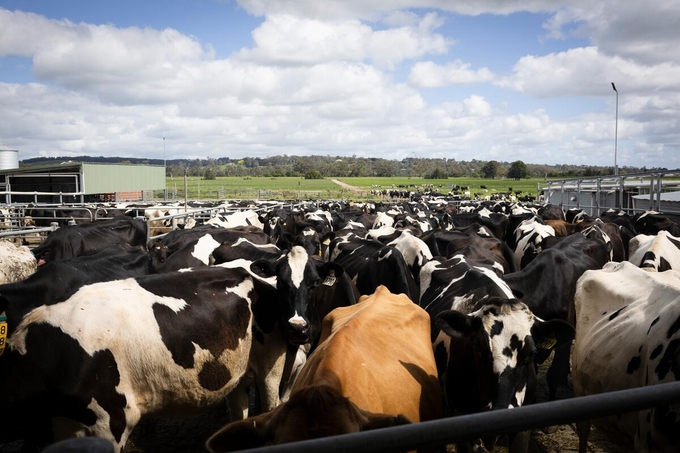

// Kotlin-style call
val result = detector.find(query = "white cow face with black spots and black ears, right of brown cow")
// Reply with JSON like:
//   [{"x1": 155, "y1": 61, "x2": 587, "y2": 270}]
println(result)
[{"x1": 435, "y1": 297, "x2": 574, "y2": 411}]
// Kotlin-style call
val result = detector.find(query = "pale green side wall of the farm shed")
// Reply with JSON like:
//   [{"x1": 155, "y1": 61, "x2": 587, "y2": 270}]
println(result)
[{"x1": 82, "y1": 163, "x2": 165, "y2": 194}]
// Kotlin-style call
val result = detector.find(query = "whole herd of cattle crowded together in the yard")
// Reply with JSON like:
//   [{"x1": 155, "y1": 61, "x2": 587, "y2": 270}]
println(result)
[{"x1": 0, "y1": 199, "x2": 680, "y2": 452}]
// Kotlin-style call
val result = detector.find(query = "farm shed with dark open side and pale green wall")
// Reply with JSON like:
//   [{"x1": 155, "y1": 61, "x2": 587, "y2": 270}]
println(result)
[{"x1": 0, "y1": 162, "x2": 165, "y2": 204}]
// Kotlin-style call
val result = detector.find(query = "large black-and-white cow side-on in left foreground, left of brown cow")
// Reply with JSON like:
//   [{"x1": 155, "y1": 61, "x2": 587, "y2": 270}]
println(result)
[{"x1": 0, "y1": 267, "x2": 286, "y2": 452}]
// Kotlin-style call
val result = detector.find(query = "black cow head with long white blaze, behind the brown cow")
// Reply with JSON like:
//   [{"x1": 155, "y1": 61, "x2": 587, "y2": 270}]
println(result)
[{"x1": 250, "y1": 245, "x2": 344, "y2": 344}]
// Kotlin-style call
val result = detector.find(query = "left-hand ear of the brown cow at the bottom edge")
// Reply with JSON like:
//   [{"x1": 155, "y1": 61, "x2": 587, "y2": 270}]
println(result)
[{"x1": 205, "y1": 412, "x2": 272, "y2": 453}]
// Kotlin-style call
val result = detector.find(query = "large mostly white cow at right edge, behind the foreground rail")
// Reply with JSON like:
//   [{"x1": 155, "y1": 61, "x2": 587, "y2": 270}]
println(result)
[{"x1": 572, "y1": 261, "x2": 680, "y2": 453}]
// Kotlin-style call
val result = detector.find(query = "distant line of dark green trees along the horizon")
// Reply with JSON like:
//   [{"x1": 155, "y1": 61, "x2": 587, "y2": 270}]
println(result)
[{"x1": 20, "y1": 155, "x2": 667, "y2": 179}]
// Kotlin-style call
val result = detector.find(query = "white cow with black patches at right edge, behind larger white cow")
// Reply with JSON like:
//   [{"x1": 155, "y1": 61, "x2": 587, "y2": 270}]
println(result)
[{"x1": 628, "y1": 230, "x2": 680, "y2": 272}]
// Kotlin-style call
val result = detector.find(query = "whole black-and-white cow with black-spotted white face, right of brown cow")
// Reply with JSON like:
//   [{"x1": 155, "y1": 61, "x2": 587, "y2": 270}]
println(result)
[{"x1": 420, "y1": 255, "x2": 573, "y2": 451}]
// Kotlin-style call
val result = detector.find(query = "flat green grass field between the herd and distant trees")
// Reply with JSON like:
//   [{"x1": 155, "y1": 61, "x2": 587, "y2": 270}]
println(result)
[{"x1": 154, "y1": 176, "x2": 544, "y2": 201}]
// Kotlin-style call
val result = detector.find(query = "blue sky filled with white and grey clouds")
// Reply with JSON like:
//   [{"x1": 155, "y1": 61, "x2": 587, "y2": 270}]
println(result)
[{"x1": 0, "y1": 0, "x2": 680, "y2": 169}]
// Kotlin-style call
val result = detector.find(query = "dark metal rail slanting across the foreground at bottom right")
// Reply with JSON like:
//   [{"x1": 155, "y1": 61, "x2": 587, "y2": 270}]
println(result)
[{"x1": 235, "y1": 382, "x2": 680, "y2": 453}]
